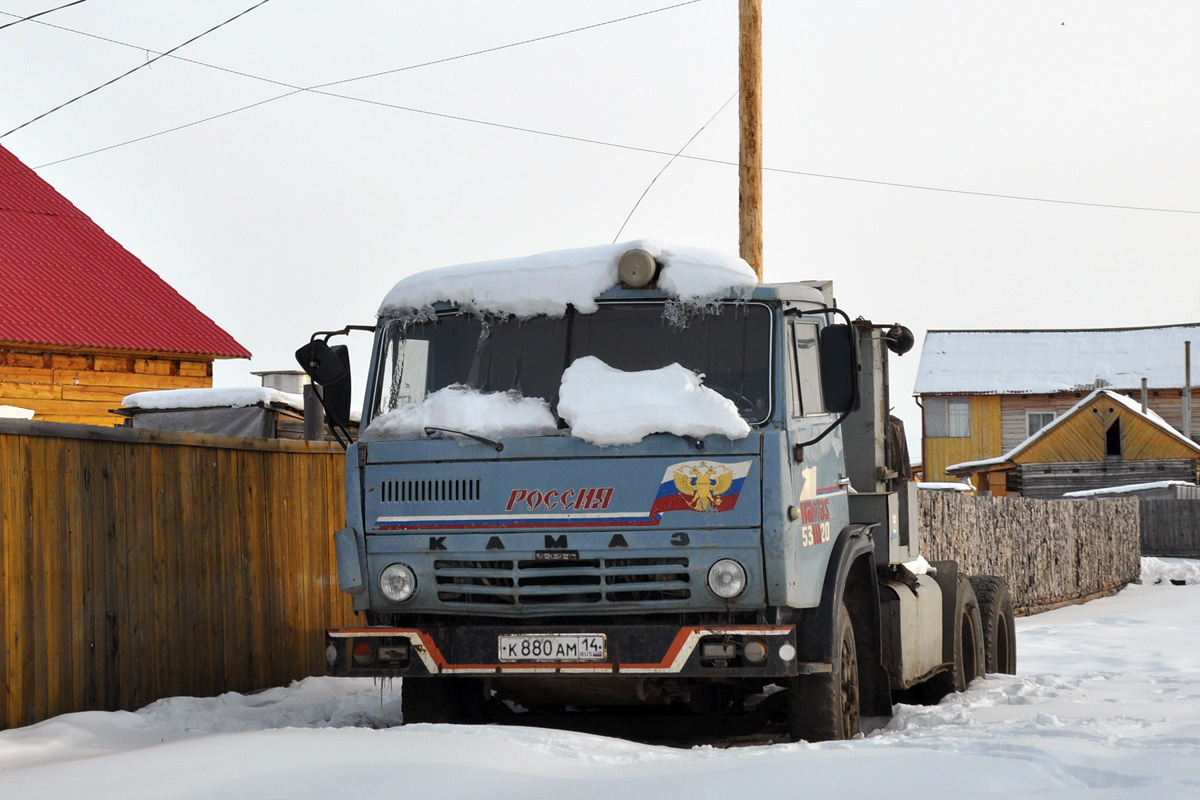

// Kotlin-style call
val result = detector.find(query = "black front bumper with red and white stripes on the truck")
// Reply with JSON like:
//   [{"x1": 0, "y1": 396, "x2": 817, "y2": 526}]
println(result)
[{"x1": 325, "y1": 624, "x2": 830, "y2": 678}]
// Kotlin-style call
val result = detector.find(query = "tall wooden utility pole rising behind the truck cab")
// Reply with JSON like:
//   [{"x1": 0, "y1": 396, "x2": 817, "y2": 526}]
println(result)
[{"x1": 738, "y1": 0, "x2": 762, "y2": 283}]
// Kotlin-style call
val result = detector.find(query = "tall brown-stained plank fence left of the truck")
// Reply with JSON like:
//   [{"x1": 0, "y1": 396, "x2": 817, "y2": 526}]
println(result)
[{"x1": 0, "y1": 420, "x2": 354, "y2": 728}]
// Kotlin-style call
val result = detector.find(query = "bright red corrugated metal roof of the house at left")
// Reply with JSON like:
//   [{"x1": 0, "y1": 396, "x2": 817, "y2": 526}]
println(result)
[{"x1": 0, "y1": 146, "x2": 250, "y2": 359}]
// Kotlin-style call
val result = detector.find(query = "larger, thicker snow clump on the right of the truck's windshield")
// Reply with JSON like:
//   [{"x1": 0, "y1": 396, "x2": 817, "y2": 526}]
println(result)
[{"x1": 558, "y1": 356, "x2": 750, "y2": 445}]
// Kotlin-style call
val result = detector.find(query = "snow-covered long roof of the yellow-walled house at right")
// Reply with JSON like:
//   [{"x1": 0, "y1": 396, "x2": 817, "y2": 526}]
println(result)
[{"x1": 913, "y1": 323, "x2": 1200, "y2": 395}]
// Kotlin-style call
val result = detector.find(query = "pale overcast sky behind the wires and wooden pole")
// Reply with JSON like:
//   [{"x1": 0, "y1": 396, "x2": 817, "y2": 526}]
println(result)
[{"x1": 0, "y1": 0, "x2": 1200, "y2": 450}]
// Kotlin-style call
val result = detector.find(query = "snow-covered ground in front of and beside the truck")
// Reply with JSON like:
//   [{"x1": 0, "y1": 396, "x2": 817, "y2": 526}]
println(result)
[{"x1": 0, "y1": 559, "x2": 1200, "y2": 800}]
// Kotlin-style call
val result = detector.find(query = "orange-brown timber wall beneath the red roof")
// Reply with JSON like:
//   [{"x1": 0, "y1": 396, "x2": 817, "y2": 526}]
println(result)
[{"x1": 0, "y1": 344, "x2": 212, "y2": 427}]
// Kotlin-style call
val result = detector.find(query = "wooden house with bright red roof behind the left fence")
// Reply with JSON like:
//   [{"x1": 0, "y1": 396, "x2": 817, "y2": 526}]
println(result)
[{"x1": 0, "y1": 148, "x2": 250, "y2": 426}]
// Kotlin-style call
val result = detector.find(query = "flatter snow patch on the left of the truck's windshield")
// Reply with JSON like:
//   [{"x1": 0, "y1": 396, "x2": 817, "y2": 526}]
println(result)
[{"x1": 362, "y1": 384, "x2": 558, "y2": 441}]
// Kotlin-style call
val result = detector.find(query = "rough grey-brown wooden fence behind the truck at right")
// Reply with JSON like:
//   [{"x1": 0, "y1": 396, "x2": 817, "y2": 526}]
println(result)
[{"x1": 919, "y1": 492, "x2": 1141, "y2": 614}]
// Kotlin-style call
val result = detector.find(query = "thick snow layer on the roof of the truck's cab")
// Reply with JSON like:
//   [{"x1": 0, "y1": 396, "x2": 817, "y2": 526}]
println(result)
[{"x1": 379, "y1": 239, "x2": 757, "y2": 318}]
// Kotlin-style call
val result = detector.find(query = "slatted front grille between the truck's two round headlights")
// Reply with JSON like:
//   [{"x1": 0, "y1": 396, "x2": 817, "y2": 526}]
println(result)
[{"x1": 433, "y1": 558, "x2": 691, "y2": 606}]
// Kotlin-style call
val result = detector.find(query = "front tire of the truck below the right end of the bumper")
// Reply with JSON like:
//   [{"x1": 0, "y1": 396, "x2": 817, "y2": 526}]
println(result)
[{"x1": 787, "y1": 604, "x2": 862, "y2": 741}]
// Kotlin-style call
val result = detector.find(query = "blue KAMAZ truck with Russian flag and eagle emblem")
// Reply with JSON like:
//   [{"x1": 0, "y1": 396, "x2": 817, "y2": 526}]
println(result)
[{"x1": 298, "y1": 247, "x2": 1015, "y2": 740}]
